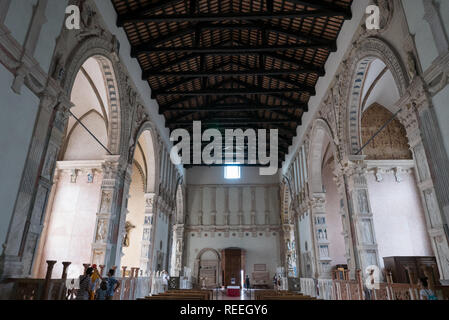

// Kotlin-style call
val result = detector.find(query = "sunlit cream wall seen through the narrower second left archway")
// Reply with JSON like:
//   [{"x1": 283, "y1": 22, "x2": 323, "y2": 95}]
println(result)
[{"x1": 121, "y1": 165, "x2": 145, "y2": 270}]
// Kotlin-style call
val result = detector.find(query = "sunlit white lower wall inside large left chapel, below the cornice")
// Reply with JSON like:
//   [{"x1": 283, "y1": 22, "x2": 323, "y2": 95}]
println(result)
[{"x1": 39, "y1": 173, "x2": 102, "y2": 278}]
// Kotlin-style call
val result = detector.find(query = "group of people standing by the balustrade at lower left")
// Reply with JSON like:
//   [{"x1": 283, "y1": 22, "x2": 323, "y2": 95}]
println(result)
[{"x1": 76, "y1": 264, "x2": 120, "y2": 300}]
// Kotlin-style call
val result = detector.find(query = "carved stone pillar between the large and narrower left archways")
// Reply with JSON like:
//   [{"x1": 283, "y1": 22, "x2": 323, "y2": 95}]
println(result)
[{"x1": 92, "y1": 156, "x2": 125, "y2": 268}]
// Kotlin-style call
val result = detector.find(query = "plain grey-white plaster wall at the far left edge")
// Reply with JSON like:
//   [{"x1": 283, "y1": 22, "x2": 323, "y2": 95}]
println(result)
[{"x1": 0, "y1": 63, "x2": 39, "y2": 243}]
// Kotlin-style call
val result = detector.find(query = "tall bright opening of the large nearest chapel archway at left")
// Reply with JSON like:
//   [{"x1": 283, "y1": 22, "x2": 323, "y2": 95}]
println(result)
[{"x1": 33, "y1": 55, "x2": 120, "y2": 278}]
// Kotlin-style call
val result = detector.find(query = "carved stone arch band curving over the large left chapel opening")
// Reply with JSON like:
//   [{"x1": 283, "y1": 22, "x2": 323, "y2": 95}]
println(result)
[{"x1": 61, "y1": 37, "x2": 123, "y2": 154}]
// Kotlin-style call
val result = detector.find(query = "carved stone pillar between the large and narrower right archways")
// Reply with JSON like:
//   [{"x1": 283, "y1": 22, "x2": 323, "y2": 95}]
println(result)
[{"x1": 346, "y1": 156, "x2": 379, "y2": 276}]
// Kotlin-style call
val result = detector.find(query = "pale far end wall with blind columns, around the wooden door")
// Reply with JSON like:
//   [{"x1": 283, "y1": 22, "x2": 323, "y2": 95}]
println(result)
[{"x1": 186, "y1": 167, "x2": 280, "y2": 276}]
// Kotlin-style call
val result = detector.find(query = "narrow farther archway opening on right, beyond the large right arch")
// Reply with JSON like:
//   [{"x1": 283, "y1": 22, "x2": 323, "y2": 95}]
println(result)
[{"x1": 309, "y1": 119, "x2": 350, "y2": 278}]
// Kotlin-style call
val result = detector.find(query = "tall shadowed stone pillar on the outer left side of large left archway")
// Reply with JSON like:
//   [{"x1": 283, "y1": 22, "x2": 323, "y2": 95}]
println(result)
[{"x1": 0, "y1": 93, "x2": 72, "y2": 278}]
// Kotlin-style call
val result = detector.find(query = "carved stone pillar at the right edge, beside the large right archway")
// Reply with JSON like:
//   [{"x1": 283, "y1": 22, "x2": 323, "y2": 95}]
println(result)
[{"x1": 399, "y1": 77, "x2": 449, "y2": 285}]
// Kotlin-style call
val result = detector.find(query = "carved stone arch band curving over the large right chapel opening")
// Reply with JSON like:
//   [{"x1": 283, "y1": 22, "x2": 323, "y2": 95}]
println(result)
[{"x1": 341, "y1": 38, "x2": 410, "y2": 155}]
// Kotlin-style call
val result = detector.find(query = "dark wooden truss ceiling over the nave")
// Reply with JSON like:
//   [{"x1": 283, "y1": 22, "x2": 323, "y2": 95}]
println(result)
[{"x1": 112, "y1": 0, "x2": 352, "y2": 164}]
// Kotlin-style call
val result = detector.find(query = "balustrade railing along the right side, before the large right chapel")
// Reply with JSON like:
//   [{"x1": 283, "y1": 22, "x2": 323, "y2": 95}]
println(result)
[{"x1": 301, "y1": 270, "x2": 449, "y2": 300}]
